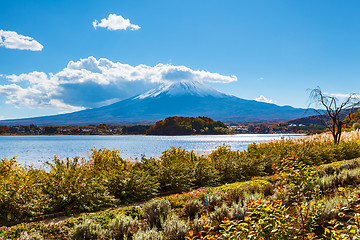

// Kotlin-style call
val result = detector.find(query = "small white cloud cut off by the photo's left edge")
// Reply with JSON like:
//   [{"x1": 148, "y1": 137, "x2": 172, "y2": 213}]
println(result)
[{"x1": 0, "y1": 29, "x2": 43, "y2": 51}]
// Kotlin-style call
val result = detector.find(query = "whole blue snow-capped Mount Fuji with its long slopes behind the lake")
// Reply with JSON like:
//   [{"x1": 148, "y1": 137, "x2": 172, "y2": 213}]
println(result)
[{"x1": 0, "y1": 81, "x2": 309, "y2": 125}]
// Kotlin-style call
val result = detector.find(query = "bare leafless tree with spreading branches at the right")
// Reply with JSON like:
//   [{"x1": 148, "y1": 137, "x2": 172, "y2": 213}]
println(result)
[{"x1": 309, "y1": 87, "x2": 360, "y2": 144}]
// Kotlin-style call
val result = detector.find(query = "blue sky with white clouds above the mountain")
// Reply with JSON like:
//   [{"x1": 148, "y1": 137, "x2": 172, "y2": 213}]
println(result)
[{"x1": 0, "y1": 0, "x2": 360, "y2": 119}]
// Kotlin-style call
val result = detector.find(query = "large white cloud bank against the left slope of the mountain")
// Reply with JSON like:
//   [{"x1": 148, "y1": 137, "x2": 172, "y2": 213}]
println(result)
[{"x1": 0, "y1": 57, "x2": 237, "y2": 112}]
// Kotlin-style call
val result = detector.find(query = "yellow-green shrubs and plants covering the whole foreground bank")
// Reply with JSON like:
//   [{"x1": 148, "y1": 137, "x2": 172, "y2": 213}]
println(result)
[{"x1": 0, "y1": 132, "x2": 360, "y2": 239}]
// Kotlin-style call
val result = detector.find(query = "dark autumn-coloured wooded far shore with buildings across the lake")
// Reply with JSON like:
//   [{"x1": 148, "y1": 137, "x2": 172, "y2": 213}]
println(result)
[{"x1": 0, "y1": 110, "x2": 360, "y2": 135}]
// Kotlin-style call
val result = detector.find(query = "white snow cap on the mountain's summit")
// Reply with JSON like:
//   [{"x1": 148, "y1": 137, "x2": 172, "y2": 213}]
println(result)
[{"x1": 135, "y1": 81, "x2": 229, "y2": 99}]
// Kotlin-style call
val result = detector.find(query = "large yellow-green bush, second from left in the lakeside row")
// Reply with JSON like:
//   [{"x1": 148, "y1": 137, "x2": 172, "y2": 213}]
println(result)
[{"x1": 43, "y1": 157, "x2": 111, "y2": 211}]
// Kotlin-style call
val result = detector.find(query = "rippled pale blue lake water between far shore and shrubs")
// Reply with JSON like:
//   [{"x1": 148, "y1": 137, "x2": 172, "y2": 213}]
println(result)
[{"x1": 0, "y1": 134, "x2": 299, "y2": 166}]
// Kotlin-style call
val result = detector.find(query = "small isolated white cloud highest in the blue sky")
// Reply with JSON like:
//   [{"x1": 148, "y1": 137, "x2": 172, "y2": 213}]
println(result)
[{"x1": 93, "y1": 14, "x2": 140, "y2": 30}]
